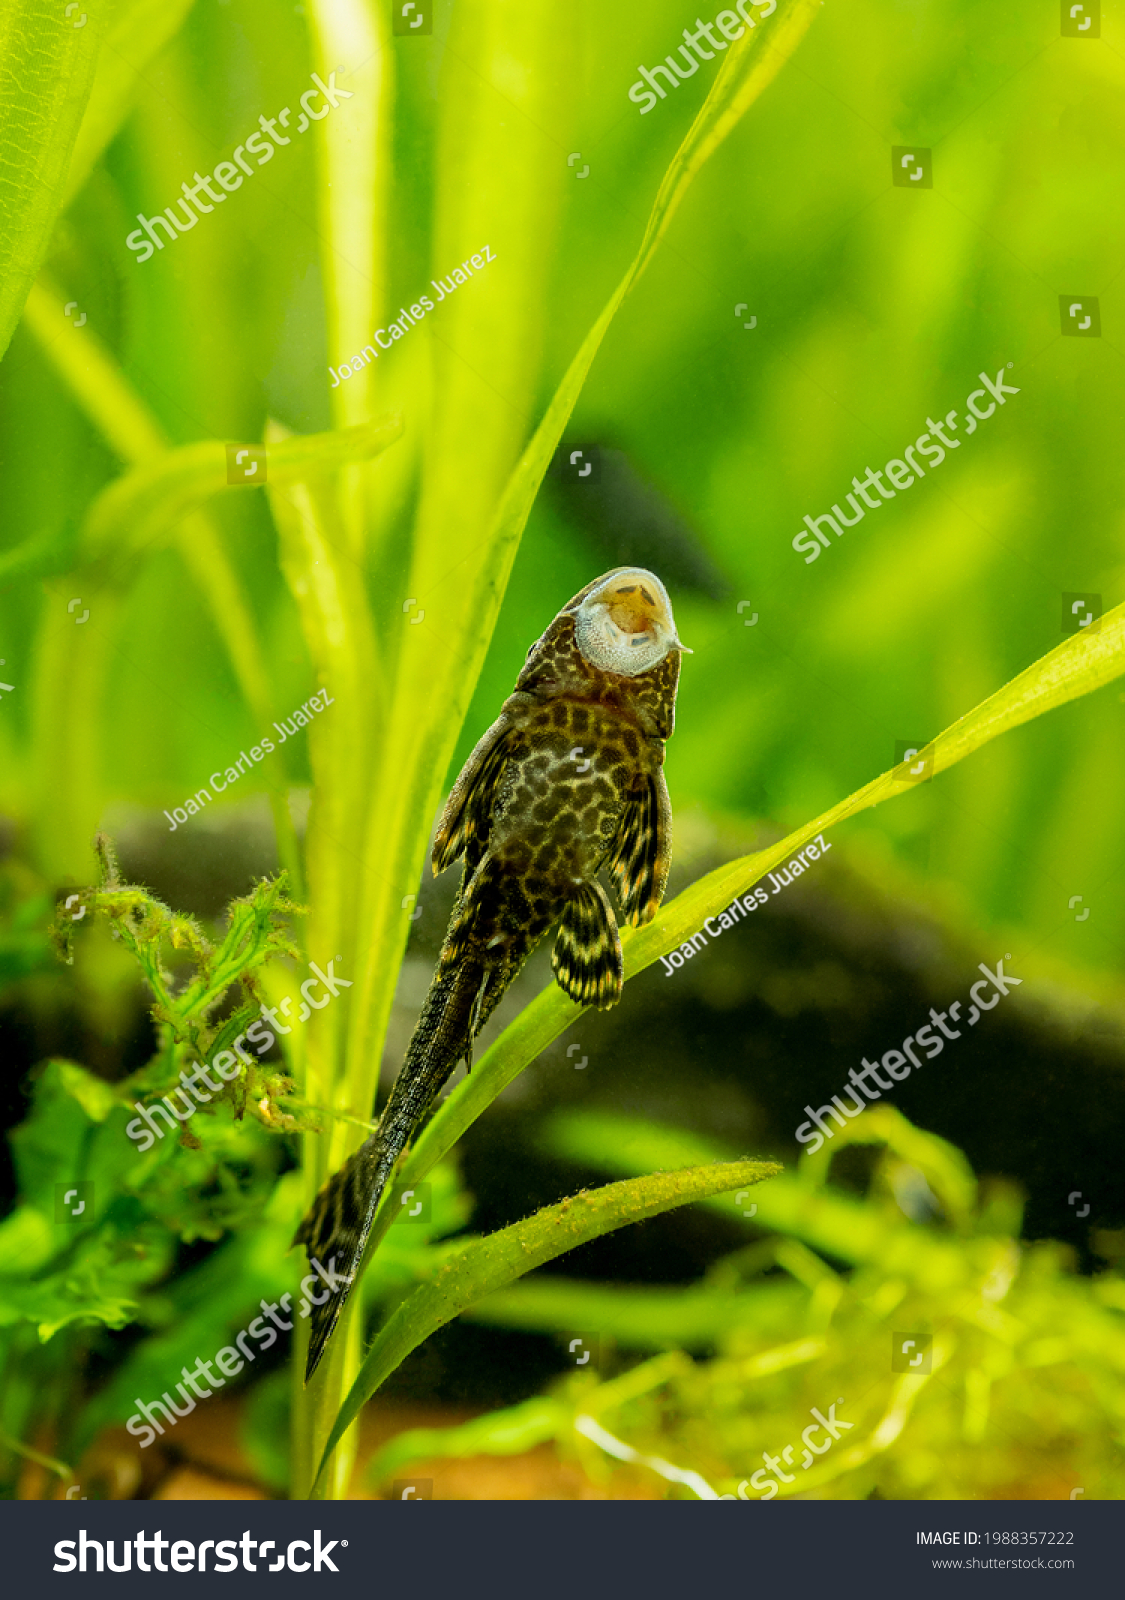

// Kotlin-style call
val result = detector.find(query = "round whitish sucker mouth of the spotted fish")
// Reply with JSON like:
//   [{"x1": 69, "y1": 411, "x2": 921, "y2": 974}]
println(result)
[{"x1": 567, "y1": 566, "x2": 690, "y2": 678}]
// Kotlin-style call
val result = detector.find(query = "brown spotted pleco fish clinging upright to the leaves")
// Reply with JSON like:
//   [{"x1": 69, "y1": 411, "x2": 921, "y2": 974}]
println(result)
[{"x1": 293, "y1": 566, "x2": 687, "y2": 1382}]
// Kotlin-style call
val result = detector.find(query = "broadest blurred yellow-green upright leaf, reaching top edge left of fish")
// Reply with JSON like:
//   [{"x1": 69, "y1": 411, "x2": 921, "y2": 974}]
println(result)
[{"x1": 347, "y1": 0, "x2": 575, "y2": 1139}]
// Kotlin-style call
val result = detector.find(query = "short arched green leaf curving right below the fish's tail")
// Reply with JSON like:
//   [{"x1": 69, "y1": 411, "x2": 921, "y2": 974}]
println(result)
[{"x1": 317, "y1": 1162, "x2": 781, "y2": 1477}]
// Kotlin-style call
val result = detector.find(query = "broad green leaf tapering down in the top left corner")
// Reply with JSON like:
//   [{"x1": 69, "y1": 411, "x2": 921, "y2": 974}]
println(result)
[{"x1": 0, "y1": 0, "x2": 104, "y2": 355}]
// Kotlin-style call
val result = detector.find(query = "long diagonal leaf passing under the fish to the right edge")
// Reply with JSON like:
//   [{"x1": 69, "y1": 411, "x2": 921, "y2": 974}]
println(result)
[{"x1": 385, "y1": 605, "x2": 1125, "y2": 1209}]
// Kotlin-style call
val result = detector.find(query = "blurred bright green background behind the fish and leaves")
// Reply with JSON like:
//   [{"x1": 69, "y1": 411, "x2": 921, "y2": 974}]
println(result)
[{"x1": 8, "y1": 0, "x2": 1125, "y2": 968}]
